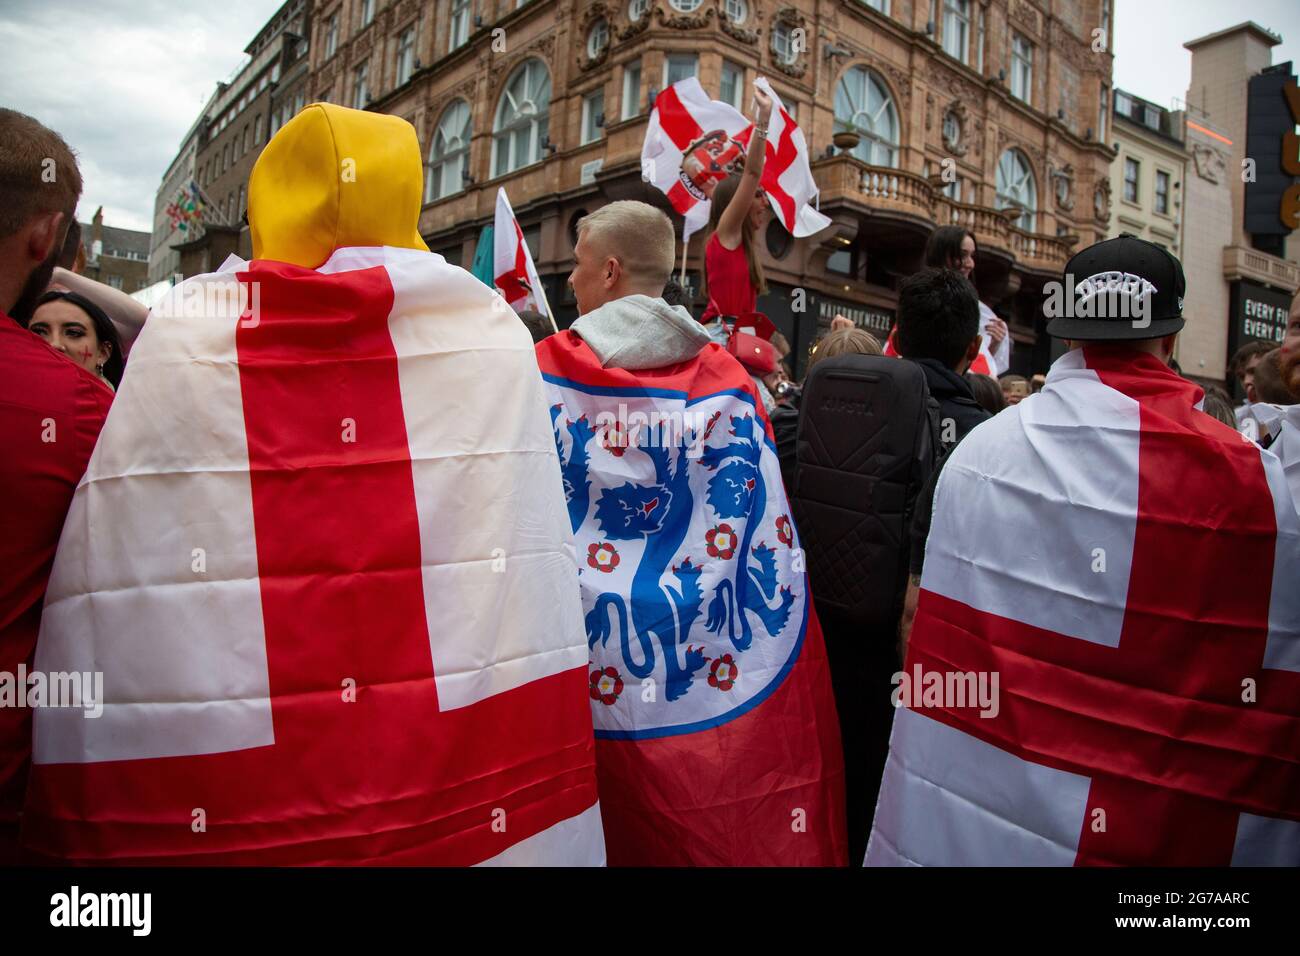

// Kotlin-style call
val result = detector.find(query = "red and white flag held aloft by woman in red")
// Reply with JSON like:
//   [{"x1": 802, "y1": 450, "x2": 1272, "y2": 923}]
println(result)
[{"x1": 641, "y1": 77, "x2": 831, "y2": 239}]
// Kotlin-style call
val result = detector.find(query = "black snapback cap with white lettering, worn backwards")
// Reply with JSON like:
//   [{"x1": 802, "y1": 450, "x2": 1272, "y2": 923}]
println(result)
[{"x1": 1045, "y1": 233, "x2": 1187, "y2": 342}]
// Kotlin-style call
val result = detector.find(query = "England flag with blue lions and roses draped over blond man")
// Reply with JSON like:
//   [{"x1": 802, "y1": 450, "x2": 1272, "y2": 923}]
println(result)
[{"x1": 538, "y1": 332, "x2": 846, "y2": 866}]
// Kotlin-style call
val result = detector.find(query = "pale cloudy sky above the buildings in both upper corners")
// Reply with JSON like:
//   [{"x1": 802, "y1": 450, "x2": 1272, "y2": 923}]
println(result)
[{"x1": 0, "y1": 0, "x2": 1300, "y2": 229}]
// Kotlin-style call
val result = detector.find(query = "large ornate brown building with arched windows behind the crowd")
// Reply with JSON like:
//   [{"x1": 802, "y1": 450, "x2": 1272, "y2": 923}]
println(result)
[{"x1": 301, "y1": 0, "x2": 1112, "y2": 371}]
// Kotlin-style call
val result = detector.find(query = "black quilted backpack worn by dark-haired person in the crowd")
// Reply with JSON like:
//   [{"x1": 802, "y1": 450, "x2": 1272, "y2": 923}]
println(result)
[{"x1": 790, "y1": 355, "x2": 944, "y2": 633}]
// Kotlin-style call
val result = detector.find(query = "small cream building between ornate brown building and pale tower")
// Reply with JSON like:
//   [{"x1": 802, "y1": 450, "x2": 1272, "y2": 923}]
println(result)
[{"x1": 1110, "y1": 90, "x2": 1187, "y2": 258}]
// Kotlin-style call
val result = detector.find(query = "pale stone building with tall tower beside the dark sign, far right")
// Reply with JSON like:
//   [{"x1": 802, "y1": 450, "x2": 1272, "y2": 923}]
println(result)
[{"x1": 1175, "y1": 23, "x2": 1300, "y2": 394}]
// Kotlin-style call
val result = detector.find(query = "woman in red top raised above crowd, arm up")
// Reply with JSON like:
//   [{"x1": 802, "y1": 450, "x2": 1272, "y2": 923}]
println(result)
[{"x1": 701, "y1": 85, "x2": 772, "y2": 323}]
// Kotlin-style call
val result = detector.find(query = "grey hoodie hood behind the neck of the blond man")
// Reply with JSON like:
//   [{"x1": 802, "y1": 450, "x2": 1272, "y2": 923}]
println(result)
[{"x1": 569, "y1": 295, "x2": 711, "y2": 371}]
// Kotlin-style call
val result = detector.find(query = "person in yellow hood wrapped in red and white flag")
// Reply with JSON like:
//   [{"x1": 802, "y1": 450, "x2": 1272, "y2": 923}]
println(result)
[{"x1": 22, "y1": 105, "x2": 603, "y2": 865}]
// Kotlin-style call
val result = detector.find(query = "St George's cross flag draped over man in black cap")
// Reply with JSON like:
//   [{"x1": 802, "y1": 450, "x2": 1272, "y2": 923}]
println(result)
[{"x1": 866, "y1": 346, "x2": 1300, "y2": 866}]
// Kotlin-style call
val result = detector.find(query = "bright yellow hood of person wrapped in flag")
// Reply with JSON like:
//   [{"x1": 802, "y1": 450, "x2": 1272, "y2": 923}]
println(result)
[{"x1": 248, "y1": 103, "x2": 429, "y2": 269}]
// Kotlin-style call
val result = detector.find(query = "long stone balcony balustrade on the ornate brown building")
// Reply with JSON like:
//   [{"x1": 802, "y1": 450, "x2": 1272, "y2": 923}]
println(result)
[{"x1": 813, "y1": 153, "x2": 1075, "y2": 273}]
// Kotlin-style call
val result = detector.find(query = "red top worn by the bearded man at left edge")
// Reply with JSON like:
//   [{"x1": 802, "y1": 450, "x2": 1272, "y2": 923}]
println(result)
[{"x1": 0, "y1": 312, "x2": 113, "y2": 865}]
